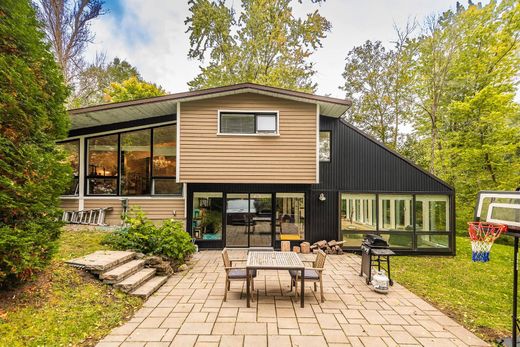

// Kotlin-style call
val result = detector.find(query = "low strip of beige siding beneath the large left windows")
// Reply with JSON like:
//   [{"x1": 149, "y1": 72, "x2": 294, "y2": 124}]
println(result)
[{"x1": 85, "y1": 198, "x2": 185, "y2": 225}]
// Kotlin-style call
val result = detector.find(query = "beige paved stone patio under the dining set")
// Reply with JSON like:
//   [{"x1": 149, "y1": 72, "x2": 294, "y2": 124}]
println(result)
[{"x1": 94, "y1": 251, "x2": 488, "y2": 347}]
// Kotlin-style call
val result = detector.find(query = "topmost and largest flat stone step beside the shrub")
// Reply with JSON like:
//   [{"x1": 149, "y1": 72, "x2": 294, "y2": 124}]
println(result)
[{"x1": 67, "y1": 251, "x2": 136, "y2": 274}]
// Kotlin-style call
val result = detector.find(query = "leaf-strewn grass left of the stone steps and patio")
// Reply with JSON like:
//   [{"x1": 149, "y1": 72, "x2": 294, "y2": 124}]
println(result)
[{"x1": 0, "y1": 231, "x2": 142, "y2": 347}]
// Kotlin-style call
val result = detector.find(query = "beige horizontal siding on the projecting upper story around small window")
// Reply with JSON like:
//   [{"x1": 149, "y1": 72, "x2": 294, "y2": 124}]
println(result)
[{"x1": 179, "y1": 93, "x2": 317, "y2": 183}]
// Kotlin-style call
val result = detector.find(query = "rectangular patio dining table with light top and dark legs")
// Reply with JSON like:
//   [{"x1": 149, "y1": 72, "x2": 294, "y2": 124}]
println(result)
[{"x1": 246, "y1": 252, "x2": 305, "y2": 307}]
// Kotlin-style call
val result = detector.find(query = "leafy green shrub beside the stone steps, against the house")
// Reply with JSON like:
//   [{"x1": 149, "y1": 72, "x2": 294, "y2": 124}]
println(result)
[{"x1": 103, "y1": 210, "x2": 195, "y2": 262}]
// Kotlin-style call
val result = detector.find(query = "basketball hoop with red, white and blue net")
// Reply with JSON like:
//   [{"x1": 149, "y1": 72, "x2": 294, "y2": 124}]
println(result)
[{"x1": 468, "y1": 222, "x2": 507, "y2": 263}]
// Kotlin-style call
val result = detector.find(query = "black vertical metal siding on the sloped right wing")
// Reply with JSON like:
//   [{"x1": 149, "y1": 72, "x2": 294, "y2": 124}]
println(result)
[{"x1": 307, "y1": 116, "x2": 455, "y2": 254}]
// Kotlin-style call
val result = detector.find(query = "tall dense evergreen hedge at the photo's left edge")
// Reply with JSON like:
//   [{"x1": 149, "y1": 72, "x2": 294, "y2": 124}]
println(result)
[{"x1": 0, "y1": 0, "x2": 71, "y2": 286}]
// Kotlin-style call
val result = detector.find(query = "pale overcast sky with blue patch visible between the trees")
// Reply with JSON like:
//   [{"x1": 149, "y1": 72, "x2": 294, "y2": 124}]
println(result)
[{"x1": 87, "y1": 0, "x2": 488, "y2": 97}]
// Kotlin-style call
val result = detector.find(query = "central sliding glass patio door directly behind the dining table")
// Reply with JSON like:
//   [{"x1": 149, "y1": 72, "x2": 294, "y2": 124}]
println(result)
[{"x1": 225, "y1": 193, "x2": 273, "y2": 247}]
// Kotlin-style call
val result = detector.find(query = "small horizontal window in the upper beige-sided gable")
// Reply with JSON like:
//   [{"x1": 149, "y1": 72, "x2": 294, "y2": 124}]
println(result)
[{"x1": 219, "y1": 112, "x2": 278, "y2": 135}]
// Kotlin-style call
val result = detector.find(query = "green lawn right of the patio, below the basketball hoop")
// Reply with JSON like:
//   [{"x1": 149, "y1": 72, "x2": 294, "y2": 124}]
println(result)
[{"x1": 392, "y1": 236, "x2": 513, "y2": 340}]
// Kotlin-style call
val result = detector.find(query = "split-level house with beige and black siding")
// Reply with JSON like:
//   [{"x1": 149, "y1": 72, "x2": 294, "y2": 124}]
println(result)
[{"x1": 61, "y1": 83, "x2": 455, "y2": 254}]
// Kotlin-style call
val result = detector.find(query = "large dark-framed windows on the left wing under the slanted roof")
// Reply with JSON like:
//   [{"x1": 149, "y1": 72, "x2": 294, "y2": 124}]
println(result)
[{"x1": 60, "y1": 125, "x2": 182, "y2": 196}]
